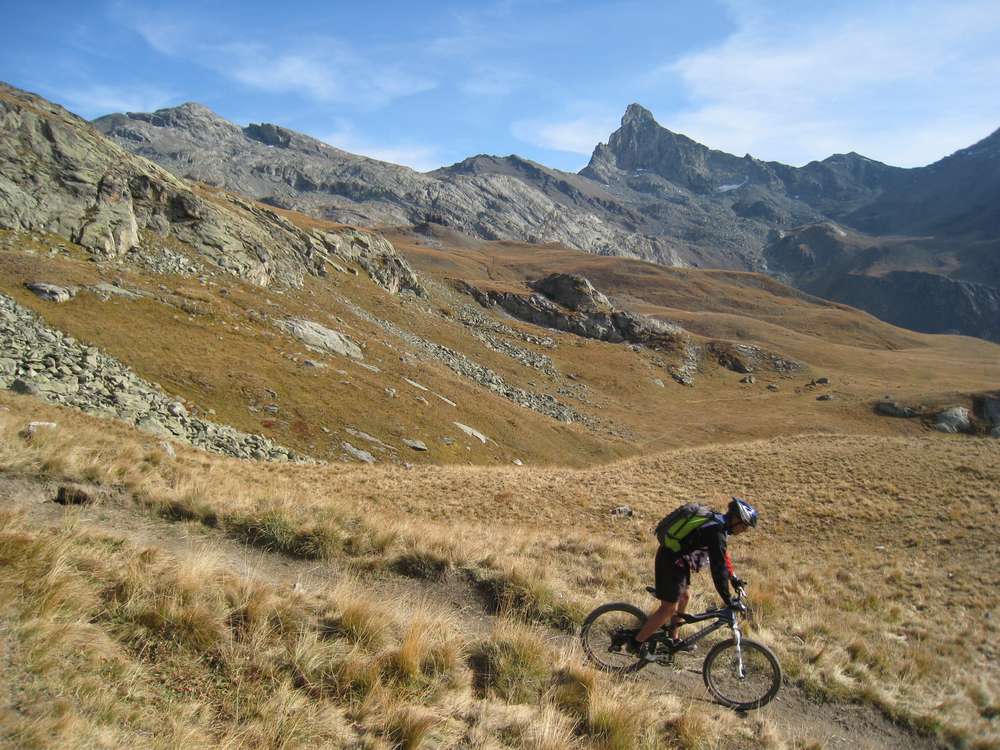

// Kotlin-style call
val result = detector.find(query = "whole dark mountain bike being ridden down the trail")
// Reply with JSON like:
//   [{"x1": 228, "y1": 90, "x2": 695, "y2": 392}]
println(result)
[{"x1": 580, "y1": 587, "x2": 781, "y2": 711}]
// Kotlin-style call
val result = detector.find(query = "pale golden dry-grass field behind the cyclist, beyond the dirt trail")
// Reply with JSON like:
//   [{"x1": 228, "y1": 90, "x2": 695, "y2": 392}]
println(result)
[{"x1": 0, "y1": 396, "x2": 1000, "y2": 748}]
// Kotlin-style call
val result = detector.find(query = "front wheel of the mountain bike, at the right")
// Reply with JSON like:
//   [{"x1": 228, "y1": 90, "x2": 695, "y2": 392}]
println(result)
[{"x1": 702, "y1": 638, "x2": 781, "y2": 711}]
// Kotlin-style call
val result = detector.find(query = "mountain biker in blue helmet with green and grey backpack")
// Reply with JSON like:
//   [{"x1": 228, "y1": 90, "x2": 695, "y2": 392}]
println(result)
[{"x1": 630, "y1": 497, "x2": 757, "y2": 658}]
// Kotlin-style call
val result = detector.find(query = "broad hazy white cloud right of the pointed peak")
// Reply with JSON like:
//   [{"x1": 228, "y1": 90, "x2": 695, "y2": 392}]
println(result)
[{"x1": 646, "y1": 0, "x2": 1000, "y2": 166}]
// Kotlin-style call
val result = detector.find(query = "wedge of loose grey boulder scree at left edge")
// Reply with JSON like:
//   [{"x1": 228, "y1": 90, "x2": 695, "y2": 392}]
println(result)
[{"x1": 0, "y1": 294, "x2": 300, "y2": 461}]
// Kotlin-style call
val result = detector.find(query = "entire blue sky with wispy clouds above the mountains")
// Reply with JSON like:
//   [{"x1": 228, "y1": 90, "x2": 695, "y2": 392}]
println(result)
[{"x1": 0, "y1": 0, "x2": 1000, "y2": 171}]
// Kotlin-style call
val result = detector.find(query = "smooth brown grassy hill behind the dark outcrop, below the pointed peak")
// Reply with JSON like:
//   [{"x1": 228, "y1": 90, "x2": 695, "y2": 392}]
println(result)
[{"x1": 389, "y1": 223, "x2": 1000, "y2": 418}]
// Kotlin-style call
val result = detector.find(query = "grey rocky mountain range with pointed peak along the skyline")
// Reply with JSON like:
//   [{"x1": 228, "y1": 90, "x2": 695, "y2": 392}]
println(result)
[{"x1": 86, "y1": 94, "x2": 1000, "y2": 338}]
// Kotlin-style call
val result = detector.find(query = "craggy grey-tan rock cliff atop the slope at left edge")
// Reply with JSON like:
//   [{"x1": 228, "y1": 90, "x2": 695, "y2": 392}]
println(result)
[{"x1": 0, "y1": 85, "x2": 423, "y2": 294}]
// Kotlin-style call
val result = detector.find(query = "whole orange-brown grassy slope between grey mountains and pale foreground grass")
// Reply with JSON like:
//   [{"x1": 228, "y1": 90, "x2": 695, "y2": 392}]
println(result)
[{"x1": 0, "y1": 203, "x2": 1000, "y2": 466}]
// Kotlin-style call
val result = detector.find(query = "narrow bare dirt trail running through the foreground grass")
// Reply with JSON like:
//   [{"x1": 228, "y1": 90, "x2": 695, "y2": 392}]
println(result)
[{"x1": 0, "y1": 472, "x2": 944, "y2": 750}]
